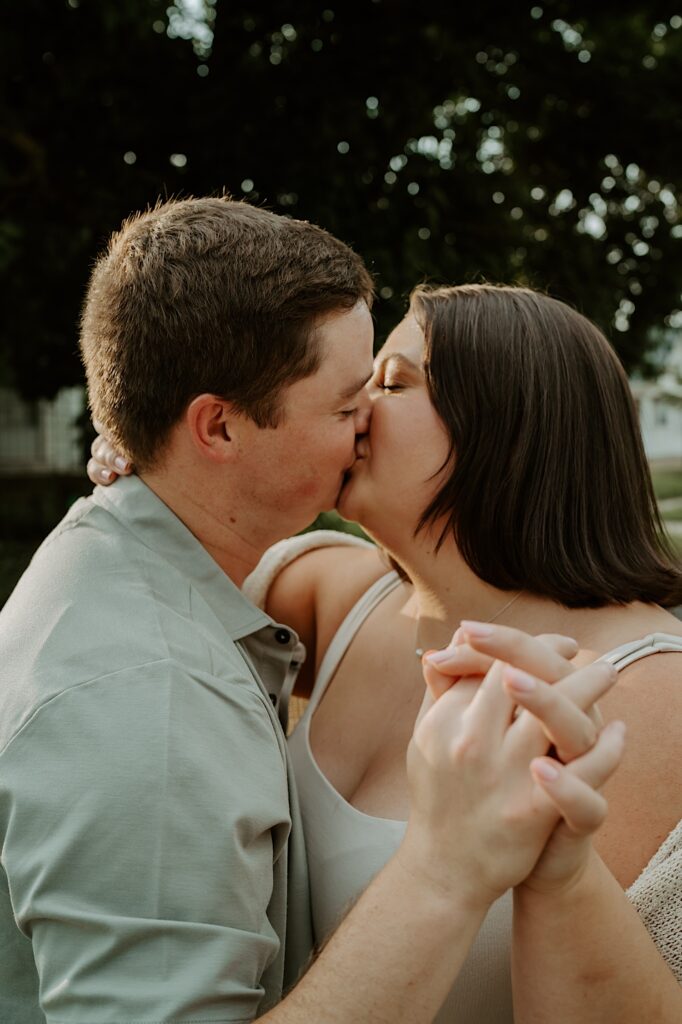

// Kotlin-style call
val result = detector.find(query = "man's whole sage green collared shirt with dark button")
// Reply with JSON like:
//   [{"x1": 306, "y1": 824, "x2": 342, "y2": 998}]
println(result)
[{"x1": 0, "y1": 477, "x2": 311, "y2": 1024}]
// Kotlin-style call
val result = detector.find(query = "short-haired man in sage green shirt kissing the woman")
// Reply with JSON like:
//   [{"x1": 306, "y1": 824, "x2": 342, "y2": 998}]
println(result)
[{"x1": 0, "y1": 199, "x2": 606, "y2": 1024}]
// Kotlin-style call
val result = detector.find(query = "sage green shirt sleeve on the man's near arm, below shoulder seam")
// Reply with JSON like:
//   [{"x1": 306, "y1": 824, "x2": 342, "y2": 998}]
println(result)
[{"x1": 0, "y1": 660, "x2": 291, "y2": 1024}]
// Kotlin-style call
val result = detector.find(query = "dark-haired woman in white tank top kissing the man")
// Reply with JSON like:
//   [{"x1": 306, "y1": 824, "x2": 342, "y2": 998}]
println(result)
[{"x1": 91, "y1": 286, "x2": 682, "y2": 1024}]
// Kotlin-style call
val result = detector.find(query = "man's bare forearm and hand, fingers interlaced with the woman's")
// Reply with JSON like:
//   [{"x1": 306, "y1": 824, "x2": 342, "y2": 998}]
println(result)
[{"x1": 264, "y1": 638, "x2": 623, "y2": 1024}]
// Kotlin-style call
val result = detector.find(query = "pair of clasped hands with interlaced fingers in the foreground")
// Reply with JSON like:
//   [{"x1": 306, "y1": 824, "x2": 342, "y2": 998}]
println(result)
[{"x1": 409, "y1": 626, "x2": 624, "y2": 895}]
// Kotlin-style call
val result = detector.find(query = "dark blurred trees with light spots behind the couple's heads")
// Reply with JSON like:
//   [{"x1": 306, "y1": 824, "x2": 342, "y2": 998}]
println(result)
[{"x1": 0, "y1": 0, "x2": 682, "y2": 604}]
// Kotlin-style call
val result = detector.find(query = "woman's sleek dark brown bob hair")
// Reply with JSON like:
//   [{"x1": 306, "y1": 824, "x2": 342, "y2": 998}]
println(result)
[{"x1": 411, "y1": 285, "x2": 682, "y2": 608}]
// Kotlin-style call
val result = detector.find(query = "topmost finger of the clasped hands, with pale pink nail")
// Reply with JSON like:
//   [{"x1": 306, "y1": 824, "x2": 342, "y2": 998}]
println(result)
[{"x1": 462, "y1": 621, "x2": 578, "y2": 683}]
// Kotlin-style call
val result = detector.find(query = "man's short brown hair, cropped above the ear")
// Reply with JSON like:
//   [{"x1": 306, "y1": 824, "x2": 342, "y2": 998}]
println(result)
[{"x1": 81, "y1": 198, "x2": 373, "y2": 469}]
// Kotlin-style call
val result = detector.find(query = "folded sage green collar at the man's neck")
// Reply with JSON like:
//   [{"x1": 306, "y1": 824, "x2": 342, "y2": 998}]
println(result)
[{"x1": 92, "y1": 476, "x2": 272, "y2": 640}]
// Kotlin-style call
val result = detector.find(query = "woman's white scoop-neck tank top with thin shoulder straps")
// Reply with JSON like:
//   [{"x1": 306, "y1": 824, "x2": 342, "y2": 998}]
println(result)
[{"x1": 289, "y1": 572, "x2": 682, "y2": 1024}]
